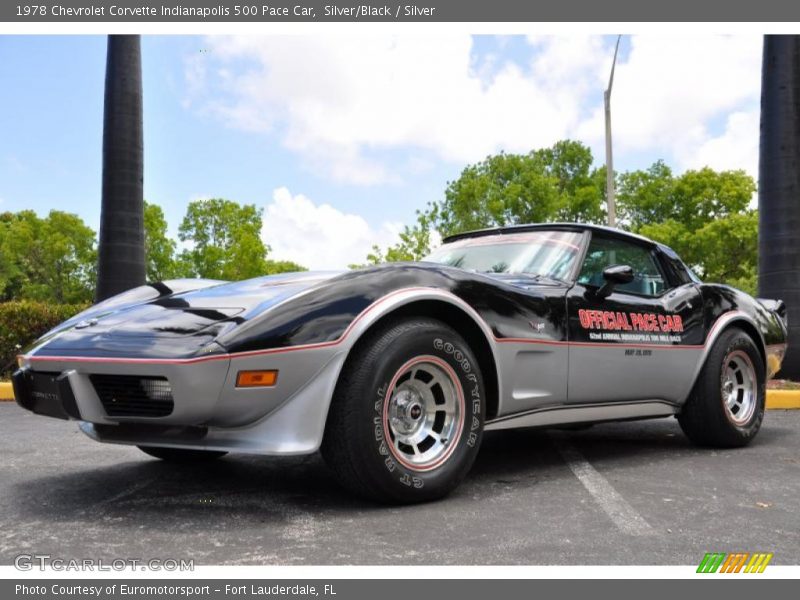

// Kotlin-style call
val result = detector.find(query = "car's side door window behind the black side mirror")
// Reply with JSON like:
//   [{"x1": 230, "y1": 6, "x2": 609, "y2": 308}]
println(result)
[{"x1": 578, "y1": 236, "x2": 668, "y2": 296}]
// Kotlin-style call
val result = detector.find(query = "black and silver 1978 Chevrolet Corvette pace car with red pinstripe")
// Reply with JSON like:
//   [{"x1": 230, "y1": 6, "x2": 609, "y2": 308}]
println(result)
[{"x1": 13, "y1": 224, "x2": 787, "y2": 502}]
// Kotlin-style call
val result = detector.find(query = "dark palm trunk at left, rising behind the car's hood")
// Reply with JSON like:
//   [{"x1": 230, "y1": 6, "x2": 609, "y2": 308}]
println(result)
[{"x1": 95, "y1": 35, "x2": 145, "y2": 302}]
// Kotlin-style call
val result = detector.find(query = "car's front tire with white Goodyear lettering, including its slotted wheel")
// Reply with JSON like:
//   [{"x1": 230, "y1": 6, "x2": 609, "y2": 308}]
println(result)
[{"x1": 322, "y1": 318, "x2": 486, "y2": 504}]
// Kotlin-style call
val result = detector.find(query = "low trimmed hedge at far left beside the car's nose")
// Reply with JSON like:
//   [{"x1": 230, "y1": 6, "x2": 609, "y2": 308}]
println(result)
[{"x1": 0, "y1": 300, "x2": 87, "y2": 376}]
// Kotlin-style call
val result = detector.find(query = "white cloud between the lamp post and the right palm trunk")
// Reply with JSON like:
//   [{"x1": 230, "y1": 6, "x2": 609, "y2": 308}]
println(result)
[{"x1": 576, "y1": 35, "x2": 761, "y2": 168}]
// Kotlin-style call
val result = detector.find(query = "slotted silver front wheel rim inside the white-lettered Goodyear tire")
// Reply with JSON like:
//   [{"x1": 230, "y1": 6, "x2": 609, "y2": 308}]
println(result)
[{"x1": 383, "y1": 356, "x2": 464, "y2": 471}]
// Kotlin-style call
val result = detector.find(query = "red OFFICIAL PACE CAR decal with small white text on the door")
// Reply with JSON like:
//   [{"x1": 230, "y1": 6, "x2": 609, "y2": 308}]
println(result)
[{"x1": 578, "y1": 309, "x2": 683, "y2": 343}]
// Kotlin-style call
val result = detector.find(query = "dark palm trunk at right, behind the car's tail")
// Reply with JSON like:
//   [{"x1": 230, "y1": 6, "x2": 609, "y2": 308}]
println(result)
[{"x1": 758, "y1": 35, "x2": 800, "y2": 379}]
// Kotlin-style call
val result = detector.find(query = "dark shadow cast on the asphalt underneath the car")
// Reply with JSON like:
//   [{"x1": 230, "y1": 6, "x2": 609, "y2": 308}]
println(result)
[{"x1": 12, "y1": 419, "x2": 788, "y2": 528}]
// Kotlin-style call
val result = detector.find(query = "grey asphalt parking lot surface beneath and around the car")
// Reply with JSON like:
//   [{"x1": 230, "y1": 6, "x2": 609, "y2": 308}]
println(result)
[{"x1": 0, "y1": 403, "x2": 800, "y2": 565}]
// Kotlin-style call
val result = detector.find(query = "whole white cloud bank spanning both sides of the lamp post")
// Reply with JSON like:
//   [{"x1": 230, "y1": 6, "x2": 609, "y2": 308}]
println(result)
[{"x1": 187, "y1": 35, "x2": 761, "y2": 184}]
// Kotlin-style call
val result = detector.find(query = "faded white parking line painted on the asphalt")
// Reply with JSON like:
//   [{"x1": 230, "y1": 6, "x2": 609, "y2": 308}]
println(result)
[{"x1": 551, "y1": 436, "x2": 653, "y2": 535}]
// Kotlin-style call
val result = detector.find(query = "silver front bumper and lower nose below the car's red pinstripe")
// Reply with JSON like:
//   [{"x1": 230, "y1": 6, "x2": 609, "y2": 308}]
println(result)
[{"x1": 13, "y1": 348, "x2": 346, "y2": 454}]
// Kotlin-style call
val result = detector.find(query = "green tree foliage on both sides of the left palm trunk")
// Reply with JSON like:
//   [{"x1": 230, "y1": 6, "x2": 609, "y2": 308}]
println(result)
[{"x1": 0, "y1": 199, "x2": 306, "y2": 312}]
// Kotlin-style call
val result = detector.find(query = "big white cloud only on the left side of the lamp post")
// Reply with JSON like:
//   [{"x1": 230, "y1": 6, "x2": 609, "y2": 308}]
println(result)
[{"x1": 188, "y1": 35, "x2": 603, "y2": 183}]
